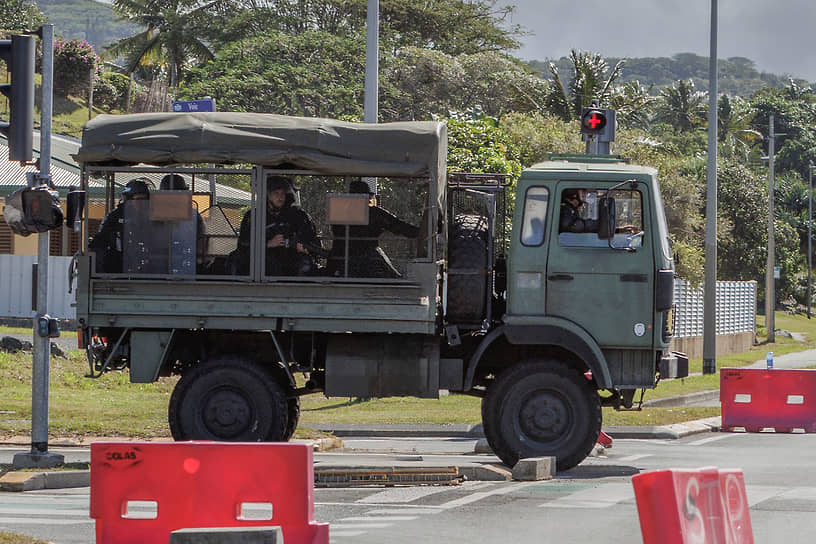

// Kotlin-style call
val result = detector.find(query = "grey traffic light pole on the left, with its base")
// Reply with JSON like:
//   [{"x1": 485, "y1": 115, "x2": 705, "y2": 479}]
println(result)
[{"x1": 13, "y1": 25, "x2": 65, "y2": 468}]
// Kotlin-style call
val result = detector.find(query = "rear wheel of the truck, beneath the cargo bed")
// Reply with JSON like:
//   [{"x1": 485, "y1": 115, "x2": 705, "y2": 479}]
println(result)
[{"x1": 168, "y1": 358, "x2": 288, "y2": 442}]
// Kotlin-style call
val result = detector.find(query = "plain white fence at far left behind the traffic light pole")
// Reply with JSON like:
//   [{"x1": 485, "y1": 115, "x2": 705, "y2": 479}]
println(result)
[{"x1": 0, "y1": 255, "x2": 76, "y2": 319}]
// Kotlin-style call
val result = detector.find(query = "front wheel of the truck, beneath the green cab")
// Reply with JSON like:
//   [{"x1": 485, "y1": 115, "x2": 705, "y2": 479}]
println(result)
[{"x1": 482, "y1": 360, "x2": 602, "y2": 470}]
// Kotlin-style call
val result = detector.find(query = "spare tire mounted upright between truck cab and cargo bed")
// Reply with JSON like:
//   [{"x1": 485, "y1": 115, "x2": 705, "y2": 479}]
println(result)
[{"x1": 446, "y1": 214, "x2": 488, "y2": 323}]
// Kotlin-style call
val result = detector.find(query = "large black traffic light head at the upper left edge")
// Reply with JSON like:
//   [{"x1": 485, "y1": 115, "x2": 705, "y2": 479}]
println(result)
[{"x1": 0, "y1": 34, "x2": 36, "y2": 163}]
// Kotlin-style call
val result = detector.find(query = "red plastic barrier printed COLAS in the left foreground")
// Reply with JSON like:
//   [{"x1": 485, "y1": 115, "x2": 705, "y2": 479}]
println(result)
[{"x1": 90, "y1": 442, "x2": 329, "y2": 544}]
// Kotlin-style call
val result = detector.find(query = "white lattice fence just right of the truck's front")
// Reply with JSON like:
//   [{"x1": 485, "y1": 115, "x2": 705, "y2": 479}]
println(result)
[{"x1": 674, "y1": 280, "x2": 757, "y2": 338}]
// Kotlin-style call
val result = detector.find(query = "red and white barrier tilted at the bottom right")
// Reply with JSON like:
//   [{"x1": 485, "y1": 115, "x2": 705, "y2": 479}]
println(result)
[{"x1": 632, "y1": 467, "x2": 754, "y2": 544}]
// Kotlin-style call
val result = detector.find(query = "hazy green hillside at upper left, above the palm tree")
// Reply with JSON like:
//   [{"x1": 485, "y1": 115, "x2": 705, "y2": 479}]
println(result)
[{"x1": 36, "y1": 0, "x2": 139, "y2": 52}]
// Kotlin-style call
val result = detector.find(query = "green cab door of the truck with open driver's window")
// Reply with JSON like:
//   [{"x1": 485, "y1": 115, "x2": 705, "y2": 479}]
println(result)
[{"x1": 546, "y1": 182, "x2": 656, "y2": 348}]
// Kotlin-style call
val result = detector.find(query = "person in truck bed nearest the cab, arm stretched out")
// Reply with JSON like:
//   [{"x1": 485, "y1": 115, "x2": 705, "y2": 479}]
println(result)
[{"x1": 328, "y1": 180, "x2": 419, "y2": 278}]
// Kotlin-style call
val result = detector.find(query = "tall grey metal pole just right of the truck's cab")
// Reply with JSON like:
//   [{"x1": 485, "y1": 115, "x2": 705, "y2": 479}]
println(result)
[{"x1": 703, "y1": 0, "x2": 717, "y2": 374}]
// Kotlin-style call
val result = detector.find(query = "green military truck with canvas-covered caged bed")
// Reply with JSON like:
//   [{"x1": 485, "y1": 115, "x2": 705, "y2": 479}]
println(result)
[{"x1": 69, "y1": 113, "x2": 688, "y2": 470}]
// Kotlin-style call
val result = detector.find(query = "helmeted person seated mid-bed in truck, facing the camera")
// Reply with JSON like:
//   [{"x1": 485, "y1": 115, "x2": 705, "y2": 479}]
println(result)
[{"x1": 237, "y1": 176, "x2": 321, "y2": 276}]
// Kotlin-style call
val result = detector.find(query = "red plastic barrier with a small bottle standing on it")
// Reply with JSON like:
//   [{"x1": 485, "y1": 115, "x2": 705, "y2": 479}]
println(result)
[{"x1": 720, "y1": 368, "x2": 816, "y2": 433}]
